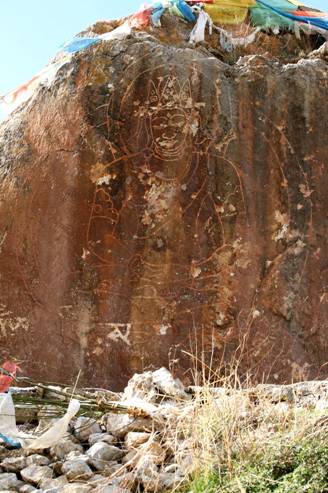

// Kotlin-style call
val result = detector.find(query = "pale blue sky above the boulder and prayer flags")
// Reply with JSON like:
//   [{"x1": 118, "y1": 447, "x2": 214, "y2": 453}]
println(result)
[{"x1": 0, "y1": 0, "x2": 328, "y2": 95}]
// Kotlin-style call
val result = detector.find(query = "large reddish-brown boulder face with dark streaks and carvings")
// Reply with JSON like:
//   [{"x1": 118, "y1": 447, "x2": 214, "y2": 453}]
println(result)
[{"x1": 0, "y1": 18, "x2": 328, "y2": 389}]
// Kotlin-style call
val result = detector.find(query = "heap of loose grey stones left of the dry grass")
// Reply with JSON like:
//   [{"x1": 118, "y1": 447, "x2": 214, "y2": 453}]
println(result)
[{"x1": 0, "y1": 368, "x2": 191, "y2": 493}]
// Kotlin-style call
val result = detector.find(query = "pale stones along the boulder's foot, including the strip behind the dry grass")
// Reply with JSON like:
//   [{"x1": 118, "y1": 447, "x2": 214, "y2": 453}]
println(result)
[{"x1": 0, "y1": 368, "x2": 328, "y2": 493}]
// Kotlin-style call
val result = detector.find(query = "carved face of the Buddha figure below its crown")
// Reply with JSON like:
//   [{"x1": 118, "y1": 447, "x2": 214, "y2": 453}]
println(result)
[{"x1": 150, "y1": 107, "x2": 191, "y2": 160}]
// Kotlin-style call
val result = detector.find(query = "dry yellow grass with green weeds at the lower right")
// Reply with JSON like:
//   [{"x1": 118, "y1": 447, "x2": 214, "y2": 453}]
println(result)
[{"x1": 174, "y1": 362, "x2": 328, "y2": 493}]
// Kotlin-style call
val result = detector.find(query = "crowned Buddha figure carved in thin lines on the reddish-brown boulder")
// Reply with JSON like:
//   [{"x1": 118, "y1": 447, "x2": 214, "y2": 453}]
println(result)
[{"x1": 87, "y1": 75, "x2": 245, "y2": 371}]
